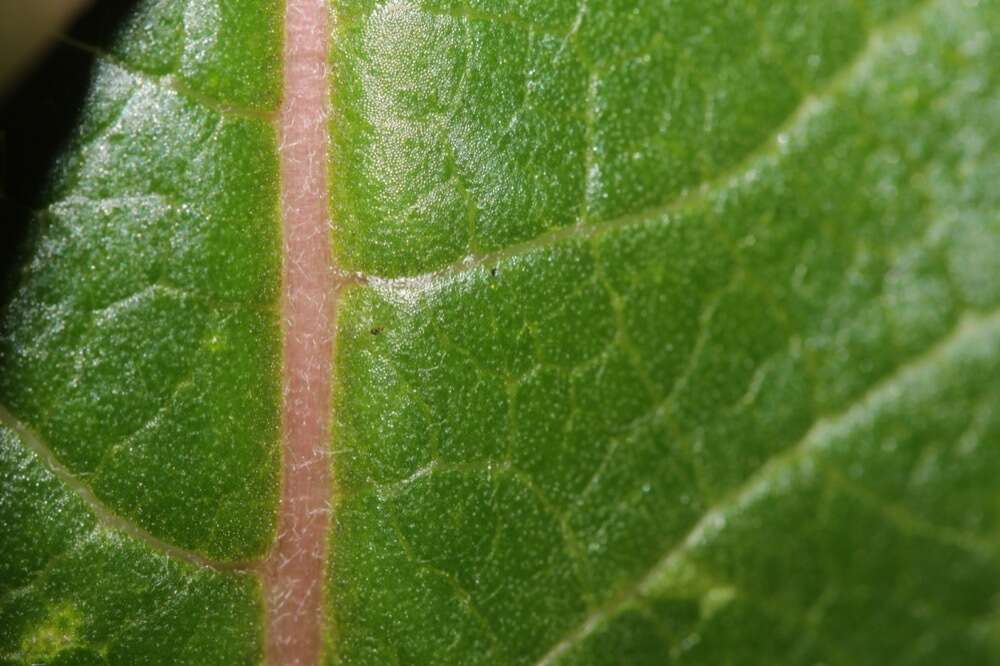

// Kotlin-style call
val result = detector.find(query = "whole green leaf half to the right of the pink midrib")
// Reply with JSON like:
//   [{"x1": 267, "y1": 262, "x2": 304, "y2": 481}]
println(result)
[{"x1": 328, "y1": 0, "x2": 1000, "y2": 665}]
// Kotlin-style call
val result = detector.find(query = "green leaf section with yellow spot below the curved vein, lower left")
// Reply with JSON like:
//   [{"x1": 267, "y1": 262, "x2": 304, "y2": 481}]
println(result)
[{"x1": 0, "y1": 414, "x2": 260, "y2": 664}]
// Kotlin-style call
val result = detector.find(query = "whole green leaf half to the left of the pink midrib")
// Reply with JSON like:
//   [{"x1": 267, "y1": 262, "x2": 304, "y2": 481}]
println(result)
[{"x1": 0, "y1": 1, "x2": 282, "y2": 665}]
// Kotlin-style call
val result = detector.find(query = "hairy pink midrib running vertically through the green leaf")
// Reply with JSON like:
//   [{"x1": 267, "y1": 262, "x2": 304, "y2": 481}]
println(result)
[{"x1": 262, "y1": 0, "x2": 337, "y2": 666}]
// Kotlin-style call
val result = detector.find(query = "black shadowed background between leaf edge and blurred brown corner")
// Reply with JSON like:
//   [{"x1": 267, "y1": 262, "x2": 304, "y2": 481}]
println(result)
[{"x1": 0, "y1": 0, "x2": 137, "y2": 288}]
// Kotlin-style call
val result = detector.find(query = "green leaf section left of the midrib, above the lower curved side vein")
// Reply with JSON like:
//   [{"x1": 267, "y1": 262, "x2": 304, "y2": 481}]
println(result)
[{"x1": 0, "y1": 2, "x2": 280, "y2": 559}]
